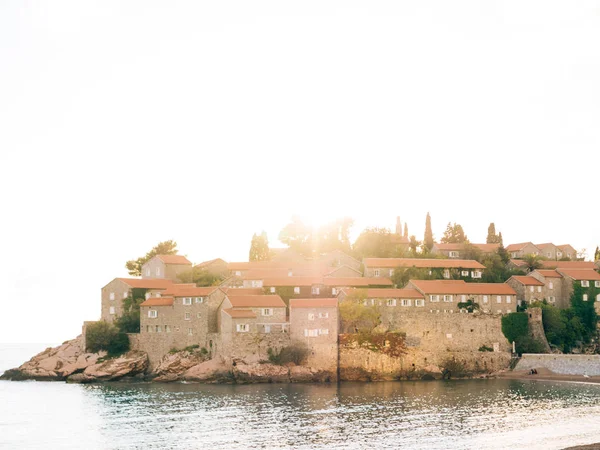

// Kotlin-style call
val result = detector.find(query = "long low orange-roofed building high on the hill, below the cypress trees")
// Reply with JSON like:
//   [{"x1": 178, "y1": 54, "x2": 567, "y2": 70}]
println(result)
[{"x1": 363, "y1": 258, "x2": 485, "y2": 280}]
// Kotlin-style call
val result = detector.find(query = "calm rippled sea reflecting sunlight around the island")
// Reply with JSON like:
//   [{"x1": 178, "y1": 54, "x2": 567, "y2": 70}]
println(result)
[{"x1": 0, "y1": 345, "x2": 600, "y2": 450}]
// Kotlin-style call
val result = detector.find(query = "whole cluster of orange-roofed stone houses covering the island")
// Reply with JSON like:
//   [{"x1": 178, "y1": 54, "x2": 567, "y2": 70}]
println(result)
[{"x1": 102, "y1": 243, "x2": 600, "y2": 366}]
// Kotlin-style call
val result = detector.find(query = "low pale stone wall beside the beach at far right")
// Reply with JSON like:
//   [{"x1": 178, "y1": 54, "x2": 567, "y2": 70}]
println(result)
[{"x1": 515, "y1": 353, "x2": 600, "y2": 376}]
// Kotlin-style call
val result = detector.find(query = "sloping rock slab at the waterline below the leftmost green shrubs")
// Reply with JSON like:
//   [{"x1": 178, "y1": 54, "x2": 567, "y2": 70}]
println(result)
[{"x1": 67, "y1": 350, "x2": 148, "y2": 383}]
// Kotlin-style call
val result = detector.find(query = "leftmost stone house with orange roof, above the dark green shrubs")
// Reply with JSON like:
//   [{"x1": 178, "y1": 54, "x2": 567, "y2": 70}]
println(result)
[{"x1": 100, "y1": 278, "x2": 173, "y2": 323}]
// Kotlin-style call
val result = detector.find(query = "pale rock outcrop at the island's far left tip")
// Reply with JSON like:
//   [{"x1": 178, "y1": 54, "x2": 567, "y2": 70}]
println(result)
[{"x1": 0, "y1": 336, "x2": 105, "y2": 381}]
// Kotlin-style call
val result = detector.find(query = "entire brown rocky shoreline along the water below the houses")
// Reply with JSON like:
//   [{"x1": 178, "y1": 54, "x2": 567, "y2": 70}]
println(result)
[{"x1": 0, "y1": 336, "x2": 337, "y2": 384}]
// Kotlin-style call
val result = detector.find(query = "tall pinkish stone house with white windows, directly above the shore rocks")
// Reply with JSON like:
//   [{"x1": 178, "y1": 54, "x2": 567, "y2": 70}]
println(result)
[{"x1": 290, "y1": 298, "x2": 339, "y2": 371}]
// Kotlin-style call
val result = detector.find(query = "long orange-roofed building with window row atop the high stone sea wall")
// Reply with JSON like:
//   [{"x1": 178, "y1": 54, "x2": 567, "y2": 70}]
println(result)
[{"x1": 406, "y1": 280, "x2": 517, "y2": 314}]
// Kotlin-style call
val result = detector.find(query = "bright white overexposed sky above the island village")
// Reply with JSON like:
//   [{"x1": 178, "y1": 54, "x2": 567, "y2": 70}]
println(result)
[{"x1": 0, "y1": 0, "x2": 600, "y2": 342}]
